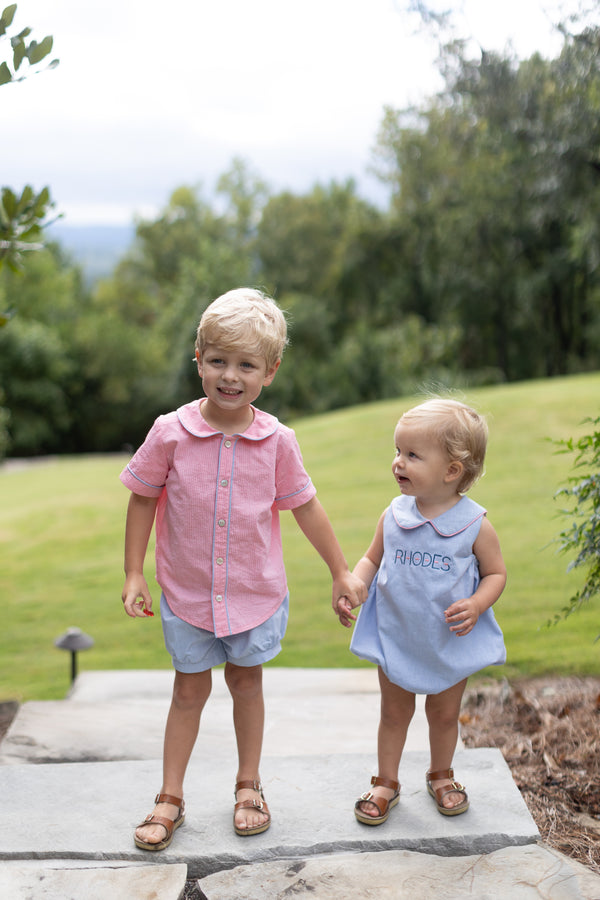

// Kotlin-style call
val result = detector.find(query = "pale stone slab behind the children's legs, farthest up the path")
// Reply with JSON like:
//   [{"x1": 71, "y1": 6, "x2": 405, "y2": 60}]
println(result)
[{"x1": 0, "y1": 666, "x2": 440, "y2": 765}]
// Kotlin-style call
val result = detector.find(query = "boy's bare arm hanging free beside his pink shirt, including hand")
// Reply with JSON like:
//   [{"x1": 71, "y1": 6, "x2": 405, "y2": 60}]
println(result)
[{"x1": 121, "y1": 494, "x2": 158, "y2": 619}]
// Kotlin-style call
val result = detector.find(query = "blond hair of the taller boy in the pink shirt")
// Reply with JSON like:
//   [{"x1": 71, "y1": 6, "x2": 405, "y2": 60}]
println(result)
[{"x1": 196, "y1": 288, "x2": 287, "y2": 370}]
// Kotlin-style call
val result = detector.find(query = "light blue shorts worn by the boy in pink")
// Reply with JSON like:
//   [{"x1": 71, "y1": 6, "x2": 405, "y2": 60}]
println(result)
[{"x1": 160, "y1": 594, "x2": 289, "y2": 673}]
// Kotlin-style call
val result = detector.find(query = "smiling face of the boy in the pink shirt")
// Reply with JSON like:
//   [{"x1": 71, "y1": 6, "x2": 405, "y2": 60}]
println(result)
[{"x1": 196, "y1": 344, "x2": 281, "y2": 411}]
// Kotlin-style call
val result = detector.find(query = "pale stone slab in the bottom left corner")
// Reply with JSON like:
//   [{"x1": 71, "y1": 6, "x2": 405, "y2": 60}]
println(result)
[{"x1": 0, "y1": 860, "x2": 187, "y2": 900}]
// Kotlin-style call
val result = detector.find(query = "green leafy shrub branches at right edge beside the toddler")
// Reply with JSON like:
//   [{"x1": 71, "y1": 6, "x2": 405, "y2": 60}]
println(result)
[{"x1": 554, "y1": 416, "x2": 600, "y2": 628}]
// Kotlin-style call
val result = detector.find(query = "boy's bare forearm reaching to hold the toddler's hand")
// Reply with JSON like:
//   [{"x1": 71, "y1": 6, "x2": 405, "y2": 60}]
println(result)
[{"x1": 292, "y1": 497, "x2": 367, "y2": 624}]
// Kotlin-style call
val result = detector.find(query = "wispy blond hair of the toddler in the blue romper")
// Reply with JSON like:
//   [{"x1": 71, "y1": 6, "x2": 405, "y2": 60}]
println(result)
[{"x1": 400, "y1": 398, "x2": 488, "y2": 494}]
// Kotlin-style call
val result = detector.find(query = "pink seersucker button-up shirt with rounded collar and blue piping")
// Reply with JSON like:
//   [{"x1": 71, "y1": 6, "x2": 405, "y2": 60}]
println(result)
[{"x1": 120, "y1": 400, "x2": 316, "y2": 637}]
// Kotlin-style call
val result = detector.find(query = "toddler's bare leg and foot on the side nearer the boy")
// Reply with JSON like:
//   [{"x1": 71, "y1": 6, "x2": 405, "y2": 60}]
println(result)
[{"x1": 359, "y1": 667, "x2": 415, "y2": 817}]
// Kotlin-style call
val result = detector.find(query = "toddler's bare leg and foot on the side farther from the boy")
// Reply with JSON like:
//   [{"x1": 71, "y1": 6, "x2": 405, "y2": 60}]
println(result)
[{"x1": 425, "y1": 678, "x2": 467, "y2": 809}]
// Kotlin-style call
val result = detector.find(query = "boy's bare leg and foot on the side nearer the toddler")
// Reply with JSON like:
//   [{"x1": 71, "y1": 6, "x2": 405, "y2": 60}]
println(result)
[{"x1": 225, "y1": 662, "x2": 268, "y2": 828}]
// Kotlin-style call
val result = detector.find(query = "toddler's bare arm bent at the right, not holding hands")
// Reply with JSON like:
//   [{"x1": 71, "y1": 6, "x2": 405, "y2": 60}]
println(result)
[{"x1": 444, "y1": 518, "x2": 506, "y2": 637}]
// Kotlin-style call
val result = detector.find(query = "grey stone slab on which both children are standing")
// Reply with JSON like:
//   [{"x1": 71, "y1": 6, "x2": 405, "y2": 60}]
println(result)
[{"x1": 0, "y1": 748, "x2": 539, "y2": 878}]
